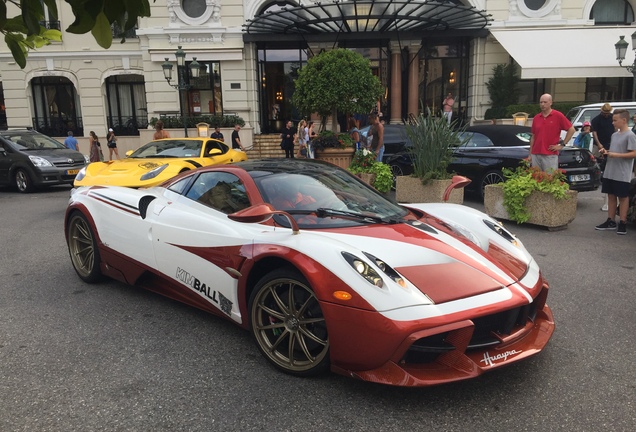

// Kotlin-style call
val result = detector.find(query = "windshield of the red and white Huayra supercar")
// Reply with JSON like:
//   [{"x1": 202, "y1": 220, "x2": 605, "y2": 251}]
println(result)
[{"x1": 253, "y1": 167, "x2": 408, "y2": 228}]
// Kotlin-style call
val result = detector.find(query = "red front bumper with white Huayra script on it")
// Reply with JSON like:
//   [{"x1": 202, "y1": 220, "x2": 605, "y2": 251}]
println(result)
[{"x1": 328, "y1": 287, "x2": 555, "y2": 387}]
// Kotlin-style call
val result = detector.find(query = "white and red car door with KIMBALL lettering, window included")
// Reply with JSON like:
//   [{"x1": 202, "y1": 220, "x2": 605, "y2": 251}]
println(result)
[{"x1": 152, "y1": 171, "x2": 253, "y2": 323}]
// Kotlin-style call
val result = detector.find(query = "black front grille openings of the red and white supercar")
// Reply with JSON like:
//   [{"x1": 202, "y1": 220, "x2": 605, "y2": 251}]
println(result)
[{"x1": 402, "y1": 296, "x2": 544, "y2": 364}]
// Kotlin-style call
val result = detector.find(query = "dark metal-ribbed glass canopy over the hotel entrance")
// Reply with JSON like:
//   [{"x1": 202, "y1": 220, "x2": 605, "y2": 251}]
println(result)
[{"x1": 243, "y1": 0, "x2": 492, "y2": 42}]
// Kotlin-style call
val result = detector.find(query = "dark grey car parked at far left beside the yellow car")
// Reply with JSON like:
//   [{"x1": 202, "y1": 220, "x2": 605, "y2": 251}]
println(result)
[{"x1": 0, "y1": 129, "x2": 89, "y2": 193}]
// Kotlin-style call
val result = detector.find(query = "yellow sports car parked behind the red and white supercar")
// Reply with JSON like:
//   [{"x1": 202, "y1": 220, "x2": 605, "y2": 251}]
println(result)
[{"x1": 74, "y1": 137, "x2": 247, "y2": 188}]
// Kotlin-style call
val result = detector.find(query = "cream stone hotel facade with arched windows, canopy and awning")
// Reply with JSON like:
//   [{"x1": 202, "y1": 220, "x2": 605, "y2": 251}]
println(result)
[{"x1": 0, "y1": 0, "x2": 636, "y2": 147}]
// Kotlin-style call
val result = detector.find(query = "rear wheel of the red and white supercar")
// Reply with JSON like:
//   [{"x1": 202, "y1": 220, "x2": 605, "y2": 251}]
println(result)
[{"x1": 66, "y1": 212, "x2": 102, "y2": 283}]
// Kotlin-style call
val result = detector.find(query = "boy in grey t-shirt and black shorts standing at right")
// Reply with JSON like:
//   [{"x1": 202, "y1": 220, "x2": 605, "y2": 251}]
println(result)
[{"x1": 596, "y1": 109, "x2": 636, "y2": 235}]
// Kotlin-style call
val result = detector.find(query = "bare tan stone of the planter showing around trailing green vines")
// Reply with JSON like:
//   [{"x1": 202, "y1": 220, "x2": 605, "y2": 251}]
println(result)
[{"x1": 484, "y1": 185, "x2": 578, "y2": 231}]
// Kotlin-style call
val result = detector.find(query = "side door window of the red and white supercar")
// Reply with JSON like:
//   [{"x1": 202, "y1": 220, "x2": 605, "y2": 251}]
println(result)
[{"x1": 186, "y1": 171, "x2": 250, "y2": 214}]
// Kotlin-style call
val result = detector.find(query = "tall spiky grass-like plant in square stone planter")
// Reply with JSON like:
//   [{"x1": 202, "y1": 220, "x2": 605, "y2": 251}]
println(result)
[{"x1": 395, "y1": 114, "x2": 464, "y2": 204}]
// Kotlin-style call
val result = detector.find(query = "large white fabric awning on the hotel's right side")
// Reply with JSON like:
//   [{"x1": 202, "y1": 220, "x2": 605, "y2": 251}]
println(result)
[{"x1": 490, "y1": 27, "x2": 634, "y2": 79}]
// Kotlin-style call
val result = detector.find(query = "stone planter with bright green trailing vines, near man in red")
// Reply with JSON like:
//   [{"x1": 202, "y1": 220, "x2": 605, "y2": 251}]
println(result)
[{"x1": 484, "y1": 161, "x2": 577, "y2": 229}]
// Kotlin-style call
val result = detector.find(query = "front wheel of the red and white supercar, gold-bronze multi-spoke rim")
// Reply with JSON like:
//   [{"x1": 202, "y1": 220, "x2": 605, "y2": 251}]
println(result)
[{"x1": 249, "y1": 268, "x2": 329, "y2": 376}]
